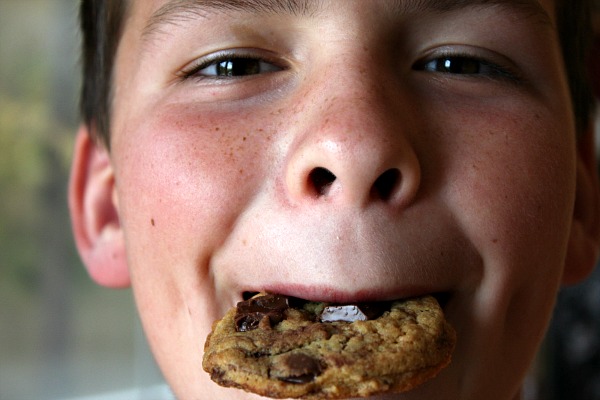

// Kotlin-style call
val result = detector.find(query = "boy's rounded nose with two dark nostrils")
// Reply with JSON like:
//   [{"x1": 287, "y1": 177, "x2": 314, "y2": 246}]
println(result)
[{"x1": 285, "y1": 70, "x2": 421, "y2": 208}]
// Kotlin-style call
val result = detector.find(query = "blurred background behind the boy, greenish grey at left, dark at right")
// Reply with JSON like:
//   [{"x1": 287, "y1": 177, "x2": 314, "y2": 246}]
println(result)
[{"x1": 0, "y1": 0, "x2": 600, "y2": 400}]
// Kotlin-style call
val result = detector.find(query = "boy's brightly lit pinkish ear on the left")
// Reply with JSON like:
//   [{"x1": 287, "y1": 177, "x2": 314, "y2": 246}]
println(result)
[{"x1": 68, "y1": 126, "x2": 130, "y2": 288}]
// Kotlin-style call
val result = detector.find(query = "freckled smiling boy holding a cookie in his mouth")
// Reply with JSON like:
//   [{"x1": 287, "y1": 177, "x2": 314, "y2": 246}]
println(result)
[{"x1": 69, "y1": 0, "x2": 600, "y2": 400}]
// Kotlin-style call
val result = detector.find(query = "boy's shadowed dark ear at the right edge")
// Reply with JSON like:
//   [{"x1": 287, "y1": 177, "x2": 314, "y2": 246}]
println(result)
[{"x1": 563, "y1": 123, "x2": 600, "y2": 285}]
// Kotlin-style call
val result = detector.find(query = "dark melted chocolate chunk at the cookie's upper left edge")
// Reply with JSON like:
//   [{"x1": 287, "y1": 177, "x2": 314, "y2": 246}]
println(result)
[{"x1": 235, "y1": 294, "x2": 289, "y2": 332}]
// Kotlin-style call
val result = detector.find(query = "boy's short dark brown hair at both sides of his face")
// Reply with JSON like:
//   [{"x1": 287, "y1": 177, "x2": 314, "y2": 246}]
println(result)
[{"x1": 80, "y1": 0, "x2": 594, "y2": 148}]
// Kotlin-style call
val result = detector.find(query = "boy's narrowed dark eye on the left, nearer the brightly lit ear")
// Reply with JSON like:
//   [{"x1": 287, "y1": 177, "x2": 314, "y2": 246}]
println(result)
[{"x1": 187, "y1": 56, "x2": 282, "y2": 78}]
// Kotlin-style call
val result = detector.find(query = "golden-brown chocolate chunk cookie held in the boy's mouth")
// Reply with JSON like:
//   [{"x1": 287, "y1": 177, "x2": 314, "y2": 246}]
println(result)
[{"x1": 203, "y1": 294, "x2": 456, "y2": 399}]
